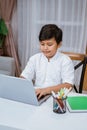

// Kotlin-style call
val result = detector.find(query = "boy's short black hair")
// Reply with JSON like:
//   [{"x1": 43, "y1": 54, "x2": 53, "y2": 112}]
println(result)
[{"x1": 39, "y1": 24, "x2": 63, "y2": 44}]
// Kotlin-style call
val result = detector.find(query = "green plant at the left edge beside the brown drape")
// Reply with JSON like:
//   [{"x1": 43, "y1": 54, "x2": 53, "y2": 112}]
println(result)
[{"x1": 0, "y1": 18, "x2": 8, "y2": 55}]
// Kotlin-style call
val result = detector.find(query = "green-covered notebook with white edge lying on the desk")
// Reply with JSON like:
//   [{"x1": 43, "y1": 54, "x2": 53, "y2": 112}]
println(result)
[{"x1": 66, "y1": 95, "x2": 87, "y2": 112}]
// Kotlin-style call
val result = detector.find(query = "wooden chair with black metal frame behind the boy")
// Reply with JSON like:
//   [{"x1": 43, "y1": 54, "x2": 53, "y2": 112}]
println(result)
[{"x1": 62, "y1": 52, "x2": 87, "y2": 93}]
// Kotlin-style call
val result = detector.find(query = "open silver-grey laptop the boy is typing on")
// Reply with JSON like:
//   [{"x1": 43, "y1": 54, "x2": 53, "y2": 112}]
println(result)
[{"x1": 0, "y1": 74, "x2": 50, "y2": 106}]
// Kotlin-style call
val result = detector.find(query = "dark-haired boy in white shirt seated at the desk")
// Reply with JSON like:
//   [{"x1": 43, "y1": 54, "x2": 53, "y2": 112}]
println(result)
[{"x1": 21, "y1": 24, "x2": 74, "y2": 99}]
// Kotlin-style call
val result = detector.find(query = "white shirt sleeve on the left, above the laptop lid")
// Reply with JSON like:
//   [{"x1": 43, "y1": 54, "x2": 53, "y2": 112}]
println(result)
[{"x1": 21, "y1": 58, "x2": 35, "y2": 80}]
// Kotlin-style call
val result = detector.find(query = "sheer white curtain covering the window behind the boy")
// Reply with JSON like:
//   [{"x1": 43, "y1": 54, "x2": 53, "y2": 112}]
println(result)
[{"x1": 17, "y1": 0, "x2": 87, "y2": 70}]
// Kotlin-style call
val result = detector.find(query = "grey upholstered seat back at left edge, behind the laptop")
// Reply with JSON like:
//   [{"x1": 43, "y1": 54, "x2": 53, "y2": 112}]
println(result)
[{"x1": 0, "y1": 56, "x2": 15, "y2": 76}]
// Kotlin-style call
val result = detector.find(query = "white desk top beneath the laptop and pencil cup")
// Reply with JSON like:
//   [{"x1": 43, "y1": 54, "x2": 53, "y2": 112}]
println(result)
[{"x1": 0, "y1": 93, "x2": 87, "y2": 130}]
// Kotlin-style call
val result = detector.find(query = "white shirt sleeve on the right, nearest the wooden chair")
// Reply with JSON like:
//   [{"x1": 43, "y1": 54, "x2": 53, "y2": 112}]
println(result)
[{"x1": 61, "y1": 56, "x2": 74, "y2": 85}]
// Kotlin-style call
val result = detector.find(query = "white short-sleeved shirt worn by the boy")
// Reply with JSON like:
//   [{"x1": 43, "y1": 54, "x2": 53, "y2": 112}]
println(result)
[{"x1": 21, "y1": 51, "x2": 74, "y2": 87}]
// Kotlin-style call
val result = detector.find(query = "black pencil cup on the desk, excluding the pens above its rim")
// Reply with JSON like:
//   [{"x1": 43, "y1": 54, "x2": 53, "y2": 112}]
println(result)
[{"x1": 53, "y1": 98, "x2": 66, "y2": 114}]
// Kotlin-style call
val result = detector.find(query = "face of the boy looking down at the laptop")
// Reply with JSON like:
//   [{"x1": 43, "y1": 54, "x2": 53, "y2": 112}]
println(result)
[{"x1": 40, "y1": 38, "x2": 60, "y2": 59}]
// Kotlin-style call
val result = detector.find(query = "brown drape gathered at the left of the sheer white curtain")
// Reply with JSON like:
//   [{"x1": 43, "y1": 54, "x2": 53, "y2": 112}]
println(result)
[{"x1": 0, "y1": 0, "x2": 21, "y2": 76}]
